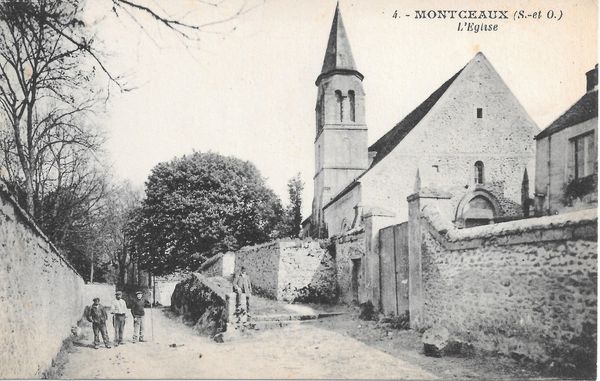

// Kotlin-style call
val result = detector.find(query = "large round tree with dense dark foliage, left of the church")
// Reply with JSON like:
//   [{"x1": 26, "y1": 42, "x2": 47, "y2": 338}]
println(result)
[{"x1": 130, "y1": 152, "x2": 282, "y2": 275}]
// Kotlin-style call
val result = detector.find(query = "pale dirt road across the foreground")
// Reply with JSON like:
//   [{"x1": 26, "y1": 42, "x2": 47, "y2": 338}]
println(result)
[{"x1": 62, "y1": 309, "x2": 435, "y2": 379}]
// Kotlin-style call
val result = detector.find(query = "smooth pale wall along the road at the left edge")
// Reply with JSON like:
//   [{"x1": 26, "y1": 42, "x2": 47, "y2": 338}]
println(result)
[{"x1": 0, "y1": 183, "x2": 84, "y2": 378}]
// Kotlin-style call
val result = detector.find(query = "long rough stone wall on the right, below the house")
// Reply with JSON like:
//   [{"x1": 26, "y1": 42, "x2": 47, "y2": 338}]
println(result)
[{"x1": 410, "y1": 203, "x2": 598, "y2": 369}]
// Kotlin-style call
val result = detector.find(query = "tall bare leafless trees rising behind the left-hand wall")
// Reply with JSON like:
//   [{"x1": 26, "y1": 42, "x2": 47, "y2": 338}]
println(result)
[{"x1": 0, "y1": 0, "x2": 262, "y2": 280}]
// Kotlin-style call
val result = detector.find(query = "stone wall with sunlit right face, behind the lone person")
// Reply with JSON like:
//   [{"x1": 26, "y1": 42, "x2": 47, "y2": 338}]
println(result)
[{"x1": 235, "y1": 240, "x2": 337, "y2": 302}]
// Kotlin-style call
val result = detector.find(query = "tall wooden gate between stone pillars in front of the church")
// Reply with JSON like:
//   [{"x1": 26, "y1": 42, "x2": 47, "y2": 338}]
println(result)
[{"x1": 379, "y1": 222, "x2": 408, "y2": 316}]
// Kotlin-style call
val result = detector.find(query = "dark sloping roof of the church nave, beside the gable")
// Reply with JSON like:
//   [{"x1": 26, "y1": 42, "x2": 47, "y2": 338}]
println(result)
[{"x1": 369, "y1": 67, "x2": 464, "y2": 168}]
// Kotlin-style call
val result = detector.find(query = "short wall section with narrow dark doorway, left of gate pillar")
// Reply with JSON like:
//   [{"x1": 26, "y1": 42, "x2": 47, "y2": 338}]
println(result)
[{"x1": 333, "y1": 228, "x2": 366, "y2": 304}]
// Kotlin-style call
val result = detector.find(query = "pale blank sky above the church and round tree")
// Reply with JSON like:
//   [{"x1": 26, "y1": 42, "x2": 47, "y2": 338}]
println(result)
[{"x1": 88, "y1": 0, "x2": 597, "y2": 217}]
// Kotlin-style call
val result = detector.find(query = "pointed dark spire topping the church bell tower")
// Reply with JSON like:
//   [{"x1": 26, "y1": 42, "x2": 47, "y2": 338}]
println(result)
[{"x1": 317, "y1": 3, "x2": 363, "y2": 84}]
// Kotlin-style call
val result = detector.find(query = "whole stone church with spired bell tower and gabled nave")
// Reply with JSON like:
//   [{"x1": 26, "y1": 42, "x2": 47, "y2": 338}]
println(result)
[{"x1": 303, "y1": 5, "x2": 539, "y2": 237}]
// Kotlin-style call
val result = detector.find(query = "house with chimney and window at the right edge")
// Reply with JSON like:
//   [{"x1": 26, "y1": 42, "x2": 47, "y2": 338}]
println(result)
[{"x1": 535, "y1": 65, "x2": 598, "y2": 215}]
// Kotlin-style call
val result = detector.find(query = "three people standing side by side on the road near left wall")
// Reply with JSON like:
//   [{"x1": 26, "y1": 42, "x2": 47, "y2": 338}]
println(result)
[{"x1": 85, "y1": 291, "x2": 146, "y2": 349}]
